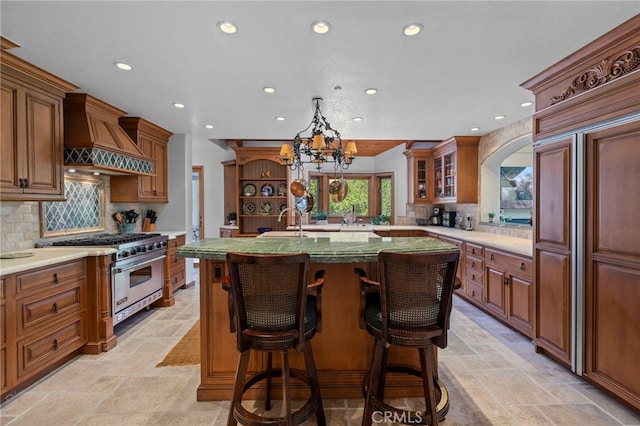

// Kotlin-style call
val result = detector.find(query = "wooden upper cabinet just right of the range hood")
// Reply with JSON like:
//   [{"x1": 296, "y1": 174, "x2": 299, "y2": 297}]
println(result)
[{"x1": 111, "y1": 117, "x2": 172, "y2": 203}]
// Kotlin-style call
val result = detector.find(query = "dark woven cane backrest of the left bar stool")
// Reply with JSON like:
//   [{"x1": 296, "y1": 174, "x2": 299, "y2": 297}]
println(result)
[{"x1": 227, "y1": 253, "x2": 309, "y2": 351}]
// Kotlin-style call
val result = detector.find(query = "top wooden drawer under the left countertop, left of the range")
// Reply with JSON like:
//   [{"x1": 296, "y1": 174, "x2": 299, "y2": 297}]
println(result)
[{"x1": 16, "y1": 259, "x2": 86, "y2": 297}]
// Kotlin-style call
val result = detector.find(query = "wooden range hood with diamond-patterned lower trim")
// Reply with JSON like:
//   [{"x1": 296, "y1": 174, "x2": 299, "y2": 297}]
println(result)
[{"x1": 64, "y1": 93, "x2": 154, "y2": 175}]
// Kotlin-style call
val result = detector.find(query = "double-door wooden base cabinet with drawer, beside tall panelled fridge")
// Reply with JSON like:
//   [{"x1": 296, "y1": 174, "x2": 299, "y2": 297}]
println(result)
[{"x1": 484, "y1": 248, "x2": 534, "y2": 337}]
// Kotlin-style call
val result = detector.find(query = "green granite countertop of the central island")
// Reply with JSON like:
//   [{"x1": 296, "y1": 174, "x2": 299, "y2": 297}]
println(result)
[{"x1": 176, "y1": 233, "x2": 457, "y2": 263}]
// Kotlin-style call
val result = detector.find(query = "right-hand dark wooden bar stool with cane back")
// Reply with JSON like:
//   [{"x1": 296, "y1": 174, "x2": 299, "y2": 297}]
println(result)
[{"x1": 355, "y1": 251, "x2": 460, "y2": 426}]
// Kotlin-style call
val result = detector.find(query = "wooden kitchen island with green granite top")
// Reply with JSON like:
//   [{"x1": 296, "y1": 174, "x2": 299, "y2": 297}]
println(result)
[{"x1": 176, "y1": 232, "x2": 457, "y2": 404}]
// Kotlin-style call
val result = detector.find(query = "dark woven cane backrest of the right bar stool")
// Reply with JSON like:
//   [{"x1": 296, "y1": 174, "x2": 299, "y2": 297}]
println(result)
[{"x1": 378, "y1": 251, "x2": 460, "y2": 346}]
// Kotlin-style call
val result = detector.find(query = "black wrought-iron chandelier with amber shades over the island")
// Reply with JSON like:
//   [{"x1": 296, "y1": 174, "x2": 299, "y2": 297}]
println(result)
[{"x1": 280, "y1": 98, "x2": 358, "y2": 170}]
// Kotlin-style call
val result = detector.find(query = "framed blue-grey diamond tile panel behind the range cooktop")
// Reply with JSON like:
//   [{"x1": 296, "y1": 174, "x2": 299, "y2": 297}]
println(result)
[{"x1": 40, "y1": 176, "x2": 105, "y2": 237}]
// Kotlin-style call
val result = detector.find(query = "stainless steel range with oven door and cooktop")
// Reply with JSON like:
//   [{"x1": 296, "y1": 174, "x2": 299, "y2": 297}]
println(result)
[{"x1": 51, "y1": 233, "x2": 167, "y2": 325}]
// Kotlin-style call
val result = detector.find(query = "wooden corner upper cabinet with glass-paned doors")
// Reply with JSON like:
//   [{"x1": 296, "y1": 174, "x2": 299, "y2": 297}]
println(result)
[{"x1": 405, "y1": 136, "x2": 480, "y2": 204}]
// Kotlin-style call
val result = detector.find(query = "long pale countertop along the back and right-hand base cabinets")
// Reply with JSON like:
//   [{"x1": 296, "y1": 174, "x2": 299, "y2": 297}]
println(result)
[{"x1": 300, "y1": 224, "x2": 533, "y2": 257}]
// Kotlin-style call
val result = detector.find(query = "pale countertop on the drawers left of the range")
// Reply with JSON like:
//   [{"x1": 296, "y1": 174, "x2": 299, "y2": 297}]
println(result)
[{"x1": 0, "y1": 247, "x2": 116, "y2": 275}]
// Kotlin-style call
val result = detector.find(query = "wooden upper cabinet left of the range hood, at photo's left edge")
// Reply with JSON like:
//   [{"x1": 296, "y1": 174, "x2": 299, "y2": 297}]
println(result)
[{"x1": 0, "y1": 39, "x2": 77, "y2": 201}]
